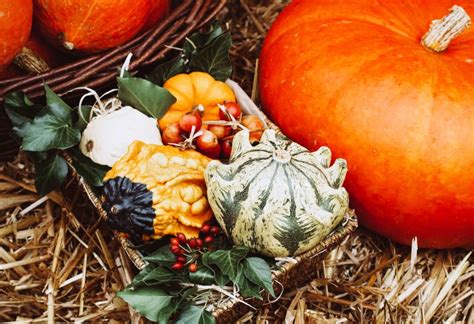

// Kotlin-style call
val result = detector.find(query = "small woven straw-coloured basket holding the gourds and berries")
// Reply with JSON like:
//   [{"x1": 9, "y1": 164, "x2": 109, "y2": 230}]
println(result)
[{"x1": 70, "y1": 112, "x2": 358, "y2": 323}]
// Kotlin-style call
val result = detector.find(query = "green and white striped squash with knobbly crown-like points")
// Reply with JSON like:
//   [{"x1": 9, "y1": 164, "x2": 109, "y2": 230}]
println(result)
[{"x1": 205, "y1": 130, "x2": 349, "y2": 257}]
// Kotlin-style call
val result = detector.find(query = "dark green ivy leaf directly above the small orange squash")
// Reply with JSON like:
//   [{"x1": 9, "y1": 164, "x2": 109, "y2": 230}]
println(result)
[{"x1": 189, "y1": 33, "x2": 232, "y2": 81}]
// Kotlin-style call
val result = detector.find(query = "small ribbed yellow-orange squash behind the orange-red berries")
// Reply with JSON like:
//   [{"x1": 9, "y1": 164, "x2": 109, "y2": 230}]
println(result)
[{"x1": 159, "y1": 72, "x2": 235, "y2": 131}]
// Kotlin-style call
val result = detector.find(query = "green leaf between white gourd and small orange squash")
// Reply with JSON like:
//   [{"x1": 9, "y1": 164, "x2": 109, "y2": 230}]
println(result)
[{"x1": 117, "y1": 78, "x2": 176, "y2": 119}]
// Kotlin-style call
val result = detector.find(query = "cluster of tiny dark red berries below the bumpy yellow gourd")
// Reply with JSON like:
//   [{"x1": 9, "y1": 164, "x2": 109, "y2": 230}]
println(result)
[{"x1": 170, "y1": 223, "x2": 220, "y2": 272}]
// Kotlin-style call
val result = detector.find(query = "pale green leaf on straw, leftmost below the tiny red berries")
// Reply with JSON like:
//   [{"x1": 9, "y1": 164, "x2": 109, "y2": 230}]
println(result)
[{"x1": 117, "y1": 288, "x2": 173, "y2": 322}]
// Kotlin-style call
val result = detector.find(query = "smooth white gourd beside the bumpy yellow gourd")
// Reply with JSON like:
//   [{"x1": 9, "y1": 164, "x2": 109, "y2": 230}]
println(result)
[{"x1": 80, "y1": 106, "x2": 163, "y2": 167}]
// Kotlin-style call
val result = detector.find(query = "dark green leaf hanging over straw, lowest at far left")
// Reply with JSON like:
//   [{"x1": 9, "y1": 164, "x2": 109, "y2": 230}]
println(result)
[{"x1": 35, "y1": 154, "x2": 68, "y2": 196}]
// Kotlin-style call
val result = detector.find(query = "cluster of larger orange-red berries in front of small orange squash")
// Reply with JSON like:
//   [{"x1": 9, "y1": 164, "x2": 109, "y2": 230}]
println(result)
[{"x1": 162, "y1": 102, "x2": 263, "y2": 159}]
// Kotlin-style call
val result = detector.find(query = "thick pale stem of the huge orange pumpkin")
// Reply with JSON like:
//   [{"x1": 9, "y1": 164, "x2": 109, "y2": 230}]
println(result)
[{"x1": 421, "y1": 6, "x2": 471, "y2": 53}]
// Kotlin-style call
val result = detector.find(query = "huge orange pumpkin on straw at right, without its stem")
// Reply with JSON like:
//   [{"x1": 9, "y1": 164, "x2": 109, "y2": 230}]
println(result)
[{"x1": 260, "y1": 0, "x2": 474, "y2": 248}]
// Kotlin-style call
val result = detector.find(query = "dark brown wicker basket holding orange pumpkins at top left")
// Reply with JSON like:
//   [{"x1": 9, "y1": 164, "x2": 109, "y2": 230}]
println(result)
[{"x1": 0, "y1": 0, "x2": 226, "y2": 161}]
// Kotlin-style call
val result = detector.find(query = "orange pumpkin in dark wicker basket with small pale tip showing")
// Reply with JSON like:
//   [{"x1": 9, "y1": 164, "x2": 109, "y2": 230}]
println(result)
[{"x1": 34, "y1": 0, "x2": 169, "y2": 53}]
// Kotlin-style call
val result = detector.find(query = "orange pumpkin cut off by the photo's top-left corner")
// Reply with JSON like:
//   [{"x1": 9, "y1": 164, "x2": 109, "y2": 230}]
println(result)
[{"x1": 0, "y1": 0, "x2": 33, "y2": 70}]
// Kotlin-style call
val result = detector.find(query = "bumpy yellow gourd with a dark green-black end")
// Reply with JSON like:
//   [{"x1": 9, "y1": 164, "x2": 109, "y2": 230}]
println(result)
[{"x1": 103, "y1": 141, "x2": 213, "y2": 239}]
